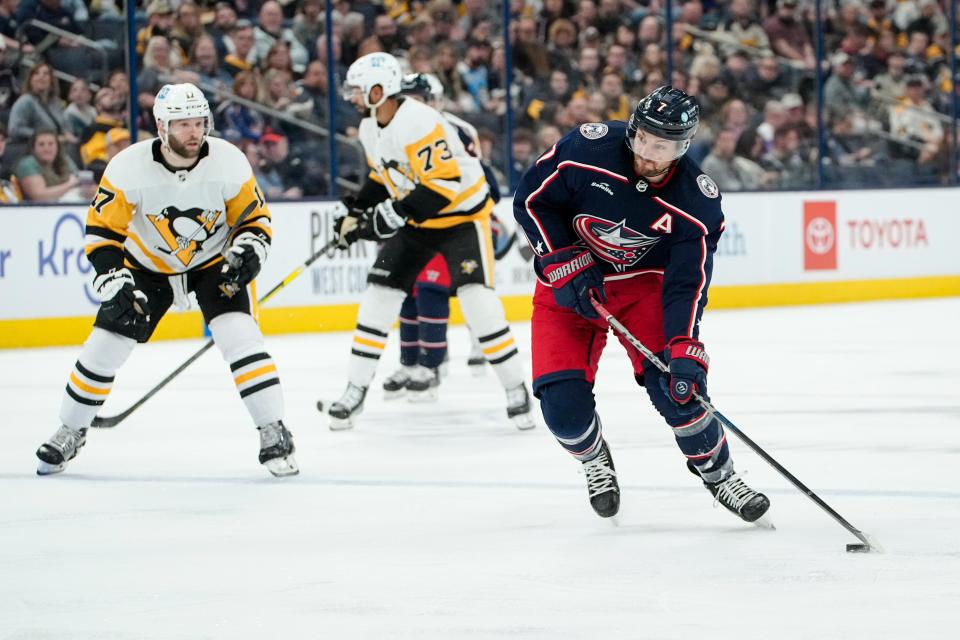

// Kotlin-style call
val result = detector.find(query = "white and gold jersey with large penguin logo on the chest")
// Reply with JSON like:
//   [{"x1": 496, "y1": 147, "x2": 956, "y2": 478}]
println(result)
[{"x1": 85, "y1": 137, "x2": 271, "y2": 275}]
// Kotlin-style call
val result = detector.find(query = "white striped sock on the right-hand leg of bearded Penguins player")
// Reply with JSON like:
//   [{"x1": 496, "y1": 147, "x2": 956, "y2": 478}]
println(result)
[{"x1": 210, "y1": 312, "x2": 283, "y2": 427}]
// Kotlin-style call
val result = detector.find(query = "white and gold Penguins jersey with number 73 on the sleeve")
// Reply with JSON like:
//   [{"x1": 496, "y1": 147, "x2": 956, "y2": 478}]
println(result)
[{"x1": 360, "y1": 99, "x2": 493, "y2": 229}]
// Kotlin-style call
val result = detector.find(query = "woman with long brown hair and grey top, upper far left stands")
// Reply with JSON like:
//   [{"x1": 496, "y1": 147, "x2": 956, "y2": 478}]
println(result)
[{"x1": 8, "y1": 62, "x2": 77, "y2": 144}]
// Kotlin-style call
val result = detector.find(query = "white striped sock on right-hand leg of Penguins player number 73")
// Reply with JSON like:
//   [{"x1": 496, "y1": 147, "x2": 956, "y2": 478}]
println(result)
[{"x1": 457, "y1": 284, "x2": 523, "y2": 389}]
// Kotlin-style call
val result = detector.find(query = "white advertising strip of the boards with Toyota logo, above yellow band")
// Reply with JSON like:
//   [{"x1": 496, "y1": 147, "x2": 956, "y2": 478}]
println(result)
[{"x1": 0, "y1": 189, "x2": 960, "y2": 321}]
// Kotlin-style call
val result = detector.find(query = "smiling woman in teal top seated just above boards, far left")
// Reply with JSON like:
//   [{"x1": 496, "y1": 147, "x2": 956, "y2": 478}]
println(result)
[{"x1": 14, "y1": 129, "x2": 80, "y2": 202}]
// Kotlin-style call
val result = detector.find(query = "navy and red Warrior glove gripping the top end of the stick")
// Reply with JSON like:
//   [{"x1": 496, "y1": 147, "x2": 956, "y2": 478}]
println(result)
[{"x1": 538, "y1": 247, "x2": 607, "y2": 320}]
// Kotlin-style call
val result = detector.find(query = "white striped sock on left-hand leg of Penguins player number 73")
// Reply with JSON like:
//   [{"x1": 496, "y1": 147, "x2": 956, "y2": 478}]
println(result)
[{"x1": 347, "y1": 284, "x2": 407, "y2": 388}]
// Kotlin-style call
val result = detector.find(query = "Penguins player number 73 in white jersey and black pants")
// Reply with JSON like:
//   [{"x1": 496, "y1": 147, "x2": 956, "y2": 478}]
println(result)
[{"x1": 329, "y1": 53, "x2": 534, "y2": 430}]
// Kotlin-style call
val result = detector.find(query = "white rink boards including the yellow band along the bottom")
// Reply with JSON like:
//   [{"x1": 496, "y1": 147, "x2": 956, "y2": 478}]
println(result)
[{"x1": 0, "y1": 188, "x2": 960, "y2": 347}]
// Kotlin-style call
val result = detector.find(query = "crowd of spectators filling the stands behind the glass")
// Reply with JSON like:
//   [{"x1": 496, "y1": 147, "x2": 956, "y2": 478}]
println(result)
[{"x1": 0, "y1": 0, "x2": 960, "y2": 202}]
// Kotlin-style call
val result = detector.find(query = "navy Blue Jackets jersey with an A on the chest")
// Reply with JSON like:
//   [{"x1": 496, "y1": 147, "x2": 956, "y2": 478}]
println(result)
[{"x1": 513, "y1": 122, "x2": 724, "y2": 341}]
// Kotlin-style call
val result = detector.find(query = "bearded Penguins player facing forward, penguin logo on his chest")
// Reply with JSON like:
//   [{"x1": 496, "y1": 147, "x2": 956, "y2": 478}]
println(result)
[{"x1": 37, "y1": 84, "x2": 298, "y2": 476}]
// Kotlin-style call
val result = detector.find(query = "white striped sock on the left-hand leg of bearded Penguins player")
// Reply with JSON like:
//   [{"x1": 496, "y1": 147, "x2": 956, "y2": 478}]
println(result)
[{"x1": 60, "y1": 327, "x2": 137, "y2": 429}]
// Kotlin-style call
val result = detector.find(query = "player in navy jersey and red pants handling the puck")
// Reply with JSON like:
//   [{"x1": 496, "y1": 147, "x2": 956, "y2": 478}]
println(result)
[{"x1": 514, "y1": 86, "x2": 770, "y2": 522}]
